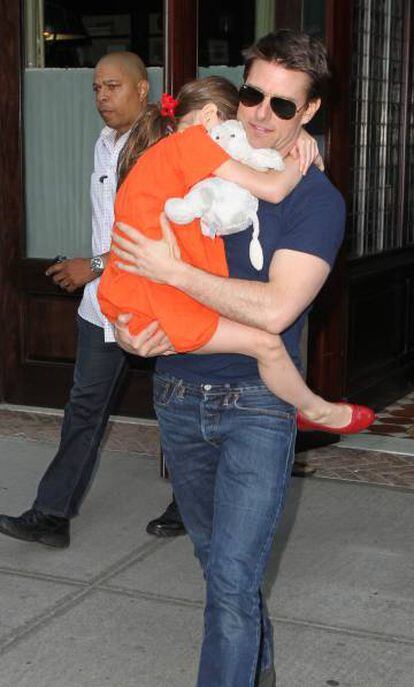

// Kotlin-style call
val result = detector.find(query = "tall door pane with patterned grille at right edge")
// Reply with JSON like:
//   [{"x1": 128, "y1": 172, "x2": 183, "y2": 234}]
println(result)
[{"x1": 349, "y1": 0, "x2": 414, "y2": 258}]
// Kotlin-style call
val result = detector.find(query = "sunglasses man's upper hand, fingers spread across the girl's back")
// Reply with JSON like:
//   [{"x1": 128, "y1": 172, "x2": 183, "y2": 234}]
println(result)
[{"x1": 112, "y1": 213, "x2": 181, "y2": 284}]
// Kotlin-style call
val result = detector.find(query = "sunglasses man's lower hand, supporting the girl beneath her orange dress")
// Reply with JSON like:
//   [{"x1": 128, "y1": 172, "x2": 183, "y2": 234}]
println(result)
[{"x1": 115, "y1": 314, "x2": 176, "y2": 358}]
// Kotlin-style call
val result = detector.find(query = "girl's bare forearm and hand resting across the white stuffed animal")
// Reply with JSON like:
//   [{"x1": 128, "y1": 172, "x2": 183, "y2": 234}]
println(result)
[{"x1": 214, "y1": 156, "x2": 302, "y2": 203}]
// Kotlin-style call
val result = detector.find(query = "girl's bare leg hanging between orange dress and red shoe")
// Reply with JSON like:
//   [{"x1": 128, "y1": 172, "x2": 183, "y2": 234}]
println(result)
[{"x1": 193, "y1": 317, "x2": 352, "y2": 427}]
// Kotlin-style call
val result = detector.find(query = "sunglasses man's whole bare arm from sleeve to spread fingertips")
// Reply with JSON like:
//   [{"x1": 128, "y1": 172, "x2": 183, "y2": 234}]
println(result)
[{"x1": 113, "y1": 215, "x2": 330, "y2": 334}]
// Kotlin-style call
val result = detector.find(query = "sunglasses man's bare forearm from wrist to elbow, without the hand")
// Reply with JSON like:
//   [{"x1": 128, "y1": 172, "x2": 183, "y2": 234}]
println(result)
[{"x1": 168, "y1": 262, "x2": 275, "y2": 331}]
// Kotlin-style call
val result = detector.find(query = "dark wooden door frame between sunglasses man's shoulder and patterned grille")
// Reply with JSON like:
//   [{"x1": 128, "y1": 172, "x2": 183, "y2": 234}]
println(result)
[{"x1": 308, "y1": 0, "x2": 353, "y2": 399}]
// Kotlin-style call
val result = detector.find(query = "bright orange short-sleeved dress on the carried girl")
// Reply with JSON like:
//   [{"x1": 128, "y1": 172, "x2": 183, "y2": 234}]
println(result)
[{"x1": 98, "y1": 126, "x2": 230, "y2": 352}]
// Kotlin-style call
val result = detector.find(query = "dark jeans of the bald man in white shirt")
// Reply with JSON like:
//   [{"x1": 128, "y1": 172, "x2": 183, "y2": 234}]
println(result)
[{"x1": 33, "y1": 317, "x2": 127, "y2": 518}]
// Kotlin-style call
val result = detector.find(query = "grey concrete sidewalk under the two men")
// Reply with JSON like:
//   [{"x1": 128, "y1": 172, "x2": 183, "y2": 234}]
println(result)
[{"x1": 0, "y1": 437, "x2": 414, "y2": 687}]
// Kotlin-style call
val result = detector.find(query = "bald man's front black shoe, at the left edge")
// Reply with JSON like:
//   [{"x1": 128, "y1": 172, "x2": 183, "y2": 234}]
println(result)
[{"x1": 0, "y1": 508, "x2": 70, "y2": 549}]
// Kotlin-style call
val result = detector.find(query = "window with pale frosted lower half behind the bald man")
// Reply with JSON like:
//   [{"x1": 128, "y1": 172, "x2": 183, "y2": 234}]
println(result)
[{"x1": 23, "y1": 0, "x2": 163, "y2": 258}]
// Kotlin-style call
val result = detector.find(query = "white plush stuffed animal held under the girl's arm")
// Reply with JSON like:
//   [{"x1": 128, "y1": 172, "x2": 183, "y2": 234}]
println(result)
[{"x1": 164, "y1": 119, "x2": 284, "y2": 270}]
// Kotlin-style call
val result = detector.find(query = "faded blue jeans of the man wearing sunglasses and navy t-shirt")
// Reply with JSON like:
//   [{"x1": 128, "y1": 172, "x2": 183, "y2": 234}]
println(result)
[{"x1": 154, "y1": 374, "x2": 296, "y2": 687}]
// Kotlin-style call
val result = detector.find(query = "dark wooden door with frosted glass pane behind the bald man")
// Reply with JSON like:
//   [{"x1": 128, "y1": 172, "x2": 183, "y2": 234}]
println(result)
[{"x1": 0, "y1": 0, "x2": 164, "y2": 417}]
